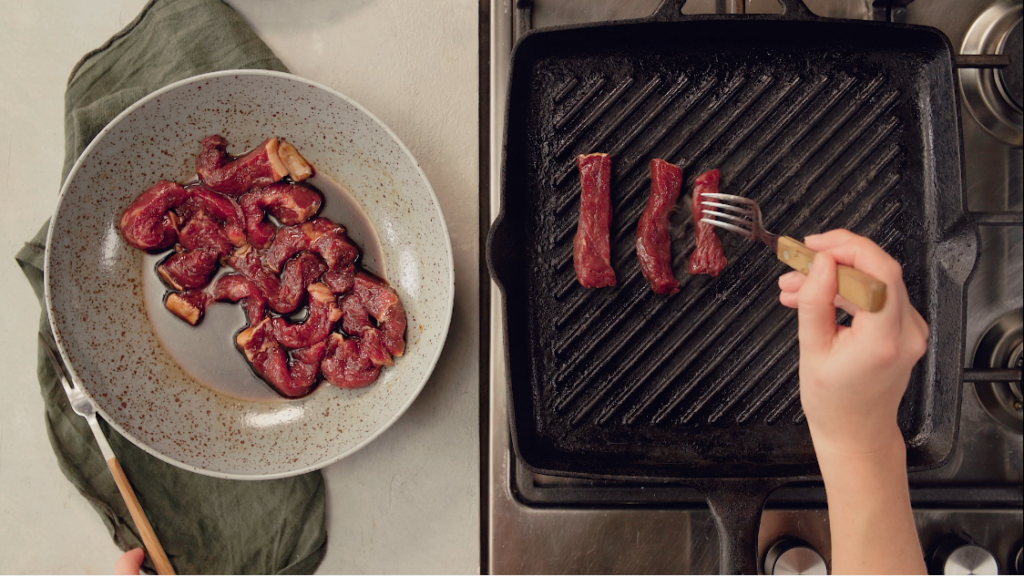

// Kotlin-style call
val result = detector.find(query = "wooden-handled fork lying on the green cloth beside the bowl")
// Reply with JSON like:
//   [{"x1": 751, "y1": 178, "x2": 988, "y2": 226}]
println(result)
[{"x1": 39, "y1": 333, "x2": 174, "y2": 574}]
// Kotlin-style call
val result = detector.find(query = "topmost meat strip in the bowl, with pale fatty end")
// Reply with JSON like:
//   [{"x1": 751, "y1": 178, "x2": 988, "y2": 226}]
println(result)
[{"x1": 196, "y1": 134, "x2": 288, "y2": 196}]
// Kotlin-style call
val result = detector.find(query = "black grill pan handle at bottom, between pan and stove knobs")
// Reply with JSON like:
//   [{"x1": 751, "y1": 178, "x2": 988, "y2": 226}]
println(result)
[{"x1": 694, "y1": 478, "x2": 785, "y2": 574}]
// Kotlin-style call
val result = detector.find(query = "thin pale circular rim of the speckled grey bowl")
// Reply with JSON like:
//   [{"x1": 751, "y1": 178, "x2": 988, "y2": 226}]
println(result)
[{"x1": 43, "y1": 70, "x2": 455, "y2": 480}]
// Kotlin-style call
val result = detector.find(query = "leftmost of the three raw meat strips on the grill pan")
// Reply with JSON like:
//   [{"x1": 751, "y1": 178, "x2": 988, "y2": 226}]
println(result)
[{"x1": 572, "y1": 153, "x2": 615, "y2": 288}]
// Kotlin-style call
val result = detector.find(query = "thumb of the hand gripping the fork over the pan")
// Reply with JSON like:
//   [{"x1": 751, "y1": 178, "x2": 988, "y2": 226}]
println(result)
[{"x1": 797, "y1": 252, "x2": 839, "y2": 357}]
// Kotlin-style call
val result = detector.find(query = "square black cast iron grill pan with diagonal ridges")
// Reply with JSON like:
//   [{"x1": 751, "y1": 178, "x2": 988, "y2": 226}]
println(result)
[{"x1": 487, "y1": 1, "x2": 977, "y2": 569}]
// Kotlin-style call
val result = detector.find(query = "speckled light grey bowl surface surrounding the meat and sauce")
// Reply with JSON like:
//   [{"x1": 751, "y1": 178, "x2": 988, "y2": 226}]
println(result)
[{"x1": 46, "y1": 71, "x2": 454, "y2": 479}]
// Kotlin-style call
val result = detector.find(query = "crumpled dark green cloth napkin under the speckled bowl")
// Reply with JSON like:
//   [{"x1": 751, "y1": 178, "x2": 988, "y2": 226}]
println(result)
[{"x1": 16, "y1": 0, "x2": 327, "y2": 574}]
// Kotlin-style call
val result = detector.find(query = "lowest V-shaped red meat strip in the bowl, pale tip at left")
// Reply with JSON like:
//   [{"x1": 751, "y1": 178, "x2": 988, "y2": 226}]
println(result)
[{"x1": 234, "y1": 318, "x2": 327, "y2": 398}]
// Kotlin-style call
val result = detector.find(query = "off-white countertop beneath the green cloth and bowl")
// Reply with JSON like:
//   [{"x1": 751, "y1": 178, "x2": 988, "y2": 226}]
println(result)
[{"x1": 0, "y1": 0, "x2": 480, "y2": 574}]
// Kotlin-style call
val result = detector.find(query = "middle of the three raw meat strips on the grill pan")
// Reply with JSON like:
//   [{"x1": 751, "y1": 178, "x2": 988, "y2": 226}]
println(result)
[{"x1": 637, "y1": 158, "x2": 683, "y2": 294}]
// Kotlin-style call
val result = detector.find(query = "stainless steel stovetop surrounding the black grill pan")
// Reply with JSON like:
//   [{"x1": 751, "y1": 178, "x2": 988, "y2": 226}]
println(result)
[{"x1": 483, "y1": 0, "x2": 1024, "y2": 573}]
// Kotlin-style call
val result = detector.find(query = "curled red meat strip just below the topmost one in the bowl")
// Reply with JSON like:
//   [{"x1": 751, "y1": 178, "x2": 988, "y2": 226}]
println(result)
[{"x1": 241, "y1": 182, "x2": 324, "y2": 248}]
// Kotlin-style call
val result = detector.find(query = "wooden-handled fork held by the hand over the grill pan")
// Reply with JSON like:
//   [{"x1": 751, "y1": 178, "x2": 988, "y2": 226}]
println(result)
[{"x1": 700, "y1": 192, "x2": 886, "y2": 312}]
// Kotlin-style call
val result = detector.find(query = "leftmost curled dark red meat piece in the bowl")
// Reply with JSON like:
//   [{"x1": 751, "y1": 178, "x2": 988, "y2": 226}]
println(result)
[{"x1": 120, "y1": 180, "x2": 188, "y2": 252}]
